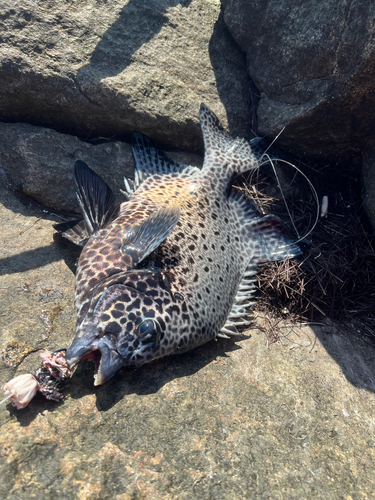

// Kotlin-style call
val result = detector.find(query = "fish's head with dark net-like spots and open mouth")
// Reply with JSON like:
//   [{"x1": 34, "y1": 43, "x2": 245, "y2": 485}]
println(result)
[{"x1": 66, "y1": 270, "x2": 181, "y2": 385}]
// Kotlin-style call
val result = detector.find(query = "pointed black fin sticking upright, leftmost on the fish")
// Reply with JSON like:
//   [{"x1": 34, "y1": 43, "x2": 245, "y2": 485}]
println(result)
[{"x1": 74, "y1": 160, "x2": 120, "y2": 235}]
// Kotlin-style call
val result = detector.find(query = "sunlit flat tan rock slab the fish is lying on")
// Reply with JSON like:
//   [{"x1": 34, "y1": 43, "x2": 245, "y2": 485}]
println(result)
[{"x1": 0, "y1": 182, "x2": 375, "y2": 500}]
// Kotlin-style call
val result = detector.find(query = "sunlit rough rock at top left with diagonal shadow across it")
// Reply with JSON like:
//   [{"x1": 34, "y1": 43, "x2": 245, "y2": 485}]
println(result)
[{"x1": 0, "y1": 0, "x2": 250, "y2": 151}]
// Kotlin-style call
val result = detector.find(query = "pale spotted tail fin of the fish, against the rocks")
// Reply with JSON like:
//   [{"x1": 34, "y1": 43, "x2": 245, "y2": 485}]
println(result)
[{"x1": 199, "y1": 104, "x2": 258, "y2": 177}]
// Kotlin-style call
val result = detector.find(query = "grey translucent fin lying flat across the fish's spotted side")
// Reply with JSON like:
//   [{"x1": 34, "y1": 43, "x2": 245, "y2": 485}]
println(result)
[{"x1": 122, "y1": 206, "x2": 181, "y2": 265}]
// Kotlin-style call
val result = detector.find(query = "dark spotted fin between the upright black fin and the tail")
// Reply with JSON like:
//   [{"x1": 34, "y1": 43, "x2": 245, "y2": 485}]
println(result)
[{"x1": 132, "y1": 132, "x2": 199, "y2": 191}]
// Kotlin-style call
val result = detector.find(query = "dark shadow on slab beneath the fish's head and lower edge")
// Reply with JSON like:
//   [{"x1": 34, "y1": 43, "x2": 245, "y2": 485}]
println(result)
[{"x1": 69, "y1": 336, "x2": 250, "y2": 411}]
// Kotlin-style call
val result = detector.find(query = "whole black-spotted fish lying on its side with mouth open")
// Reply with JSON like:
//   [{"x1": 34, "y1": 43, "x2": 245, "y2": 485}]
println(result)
[{"x1": 59, "y1": 105, "x2": 301, "y2": 385}]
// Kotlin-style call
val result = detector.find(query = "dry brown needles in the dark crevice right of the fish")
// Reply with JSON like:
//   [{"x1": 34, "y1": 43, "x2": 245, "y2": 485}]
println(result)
[{"x1": 241, "y1": 156, "x2": 375, "y2": 341}]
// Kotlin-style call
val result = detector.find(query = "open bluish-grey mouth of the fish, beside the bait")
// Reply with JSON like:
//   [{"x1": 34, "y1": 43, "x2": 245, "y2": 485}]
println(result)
[{"x1": 65, "y1": 337, "x2": 123, "y2": 386}]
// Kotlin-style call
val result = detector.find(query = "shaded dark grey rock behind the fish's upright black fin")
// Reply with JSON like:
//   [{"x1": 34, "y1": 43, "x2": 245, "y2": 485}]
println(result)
[{"x1": 0, "y1": 123, "x2": 202, "y2": 212}]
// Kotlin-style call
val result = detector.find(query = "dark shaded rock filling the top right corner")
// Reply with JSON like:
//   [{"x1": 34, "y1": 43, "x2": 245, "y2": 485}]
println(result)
[{"x1": 222, "y1": 0, "x2": 375, "y2": 162}]
